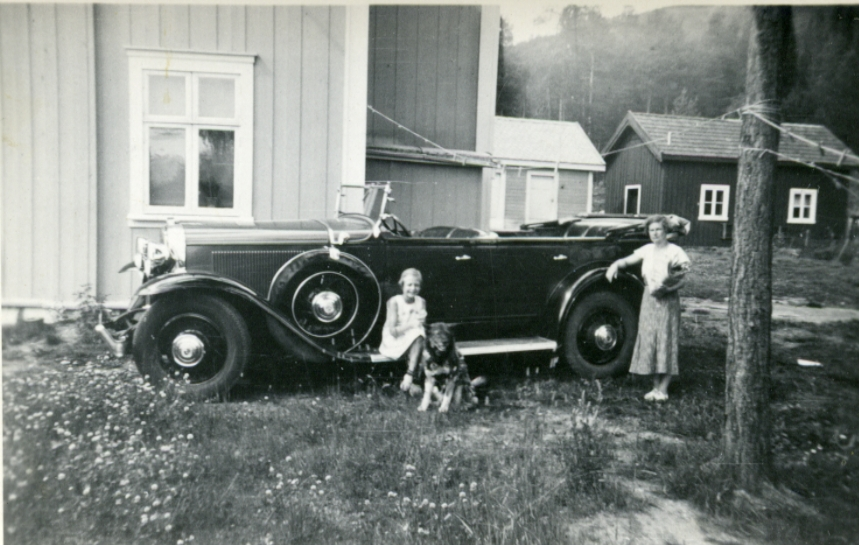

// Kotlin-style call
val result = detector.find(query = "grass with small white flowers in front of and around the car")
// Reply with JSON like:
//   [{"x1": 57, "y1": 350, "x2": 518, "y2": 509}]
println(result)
[{"x1": 3, "y1": 250, "x2": 859, "y2": 545}]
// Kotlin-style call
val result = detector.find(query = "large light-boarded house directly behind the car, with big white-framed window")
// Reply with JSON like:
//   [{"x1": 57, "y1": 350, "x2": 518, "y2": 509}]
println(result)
[{"x1": 0, "y1": 3, "x2": 499, "y2": 309}]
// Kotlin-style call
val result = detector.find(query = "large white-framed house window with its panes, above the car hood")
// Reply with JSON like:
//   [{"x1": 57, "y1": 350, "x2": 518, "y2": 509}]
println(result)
[{"x1": 128, "y1": 50, "x2": 254, "y2": 223}]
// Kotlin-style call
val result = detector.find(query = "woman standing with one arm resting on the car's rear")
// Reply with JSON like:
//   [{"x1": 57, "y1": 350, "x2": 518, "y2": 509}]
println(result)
[{"x1": 605, "y1": 216, "x2": 690, "y2": 401}]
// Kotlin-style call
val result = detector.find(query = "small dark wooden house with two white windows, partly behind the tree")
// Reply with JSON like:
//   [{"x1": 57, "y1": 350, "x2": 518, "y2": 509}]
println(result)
[{"x1": 603, "y1": 112, "x2": 859, "y2": 246}]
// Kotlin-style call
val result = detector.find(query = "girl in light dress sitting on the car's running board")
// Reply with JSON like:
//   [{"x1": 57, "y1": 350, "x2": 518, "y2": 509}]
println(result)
[{"x1": 379, "y1": 269, "x2": 427, "y2": 386}]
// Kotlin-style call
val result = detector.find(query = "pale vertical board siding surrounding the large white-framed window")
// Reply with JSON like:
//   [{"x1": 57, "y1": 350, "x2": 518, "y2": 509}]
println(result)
[{"x1": 94, "y1": 4, "x2": 345, "y2": 300}]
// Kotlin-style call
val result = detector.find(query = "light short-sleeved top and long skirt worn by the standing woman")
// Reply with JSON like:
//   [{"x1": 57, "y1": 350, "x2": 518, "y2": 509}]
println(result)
[{"x1": 629, "y1": 243, "x2": 689, "y2": 375}]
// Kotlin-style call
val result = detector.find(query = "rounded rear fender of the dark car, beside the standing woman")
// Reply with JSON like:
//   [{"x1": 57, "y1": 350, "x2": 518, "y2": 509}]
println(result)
[{"x1": 545, "y1": 266, "x2": 644, "y2": 340}]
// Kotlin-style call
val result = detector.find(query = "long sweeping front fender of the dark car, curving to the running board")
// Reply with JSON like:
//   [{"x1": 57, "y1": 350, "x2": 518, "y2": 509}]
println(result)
[{"x1": 132, "y1": 272, "x2": 367, "y2": 363}]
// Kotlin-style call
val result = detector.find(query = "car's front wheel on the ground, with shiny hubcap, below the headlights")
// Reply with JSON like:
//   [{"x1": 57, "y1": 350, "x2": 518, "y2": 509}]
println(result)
[{"x1": 133, "y1": 295, "x2": 251, "y2": 398}]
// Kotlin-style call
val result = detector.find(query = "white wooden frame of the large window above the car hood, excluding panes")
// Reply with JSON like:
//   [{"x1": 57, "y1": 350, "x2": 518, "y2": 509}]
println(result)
[{"x1": 127, "y1": 49, "x2": 256, "y2": 226}]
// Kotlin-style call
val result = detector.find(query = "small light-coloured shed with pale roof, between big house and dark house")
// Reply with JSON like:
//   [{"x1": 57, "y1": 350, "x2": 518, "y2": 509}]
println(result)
[{"x1": 489, "y1": 117, "x2": 605, "y2": 230}]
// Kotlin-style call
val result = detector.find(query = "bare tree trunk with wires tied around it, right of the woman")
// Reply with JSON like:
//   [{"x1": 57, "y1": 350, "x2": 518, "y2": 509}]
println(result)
[{"x1": 723, "y1": 7, "x2": 791, "y2": 492}]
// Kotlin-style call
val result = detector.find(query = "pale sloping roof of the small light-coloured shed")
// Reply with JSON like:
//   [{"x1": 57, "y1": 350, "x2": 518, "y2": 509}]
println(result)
[{"x1": 493, "y1": 117, "x2": 605, "y2": 171}]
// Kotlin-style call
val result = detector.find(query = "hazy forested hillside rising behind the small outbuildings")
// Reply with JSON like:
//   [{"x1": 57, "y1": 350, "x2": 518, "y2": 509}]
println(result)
[{"x1": 497, "y1": 5, "x2": 859, "y2": 151}]
